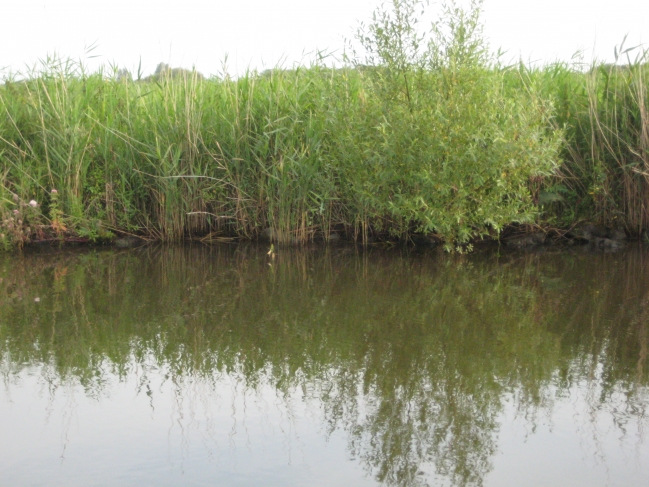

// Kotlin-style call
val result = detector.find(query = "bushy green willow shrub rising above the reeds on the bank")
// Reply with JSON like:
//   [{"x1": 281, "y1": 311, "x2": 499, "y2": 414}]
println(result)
[{"x1": 330, "y1": 0, "x2": 561, "y2": 250}]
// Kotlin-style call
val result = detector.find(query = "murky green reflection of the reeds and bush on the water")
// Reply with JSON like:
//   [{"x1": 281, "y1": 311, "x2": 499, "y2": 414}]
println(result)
[{"x1": 0, "y1": 246, "x2": 649, "y2": 486}]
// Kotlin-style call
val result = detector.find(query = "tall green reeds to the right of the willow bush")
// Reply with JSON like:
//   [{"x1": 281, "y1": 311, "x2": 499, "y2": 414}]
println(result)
[{"x1": 509, "y1": 43, "x2": 649, "y2": 235}]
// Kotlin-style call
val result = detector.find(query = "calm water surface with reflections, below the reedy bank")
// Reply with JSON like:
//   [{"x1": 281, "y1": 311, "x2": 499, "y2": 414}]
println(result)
[{"x1": 0, "y1": 246, "x2": 649, "y2": 487}]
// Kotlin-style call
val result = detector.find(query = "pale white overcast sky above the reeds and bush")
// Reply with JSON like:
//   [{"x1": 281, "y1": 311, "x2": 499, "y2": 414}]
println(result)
[{"x1": 0, "y1": 0, "x2": 649, "y2": 75}]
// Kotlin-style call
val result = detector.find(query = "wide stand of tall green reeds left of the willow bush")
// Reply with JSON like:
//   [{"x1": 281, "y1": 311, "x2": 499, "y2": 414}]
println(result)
[{"x1": 0, "y1": 62, "x2": 342, "y2": 244}]
